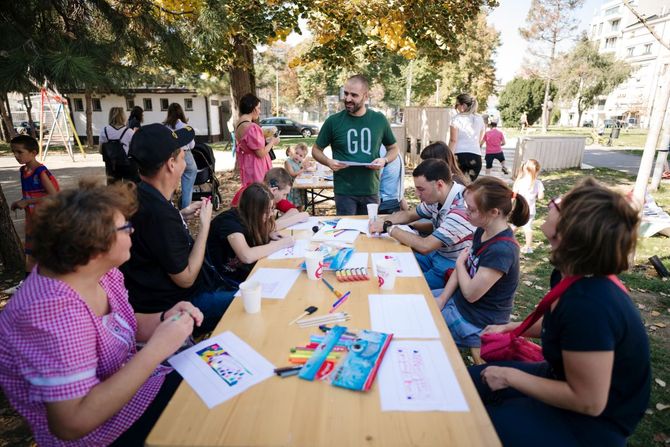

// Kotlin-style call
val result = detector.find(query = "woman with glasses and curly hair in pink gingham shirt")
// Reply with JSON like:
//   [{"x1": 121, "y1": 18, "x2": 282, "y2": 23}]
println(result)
[{"x1": 0, "y1": 183, "x2": 203, "y2": 446}]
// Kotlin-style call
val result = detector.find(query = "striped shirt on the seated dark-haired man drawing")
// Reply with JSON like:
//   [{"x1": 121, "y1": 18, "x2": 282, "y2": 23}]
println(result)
[{"x1": 416, "y1": 183, "x2": 475, "y2": 261}]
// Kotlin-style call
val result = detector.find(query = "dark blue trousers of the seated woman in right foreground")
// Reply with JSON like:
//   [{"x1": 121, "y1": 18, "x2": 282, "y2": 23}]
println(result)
[{"x1": 468, "y1": 362, "x2": 626, "y2": 447}]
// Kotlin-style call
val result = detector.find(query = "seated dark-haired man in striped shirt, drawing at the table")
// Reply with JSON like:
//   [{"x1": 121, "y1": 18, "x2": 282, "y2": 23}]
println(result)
[{"x1": 370, "y1": 159, "x2": 475, "y2": 289}]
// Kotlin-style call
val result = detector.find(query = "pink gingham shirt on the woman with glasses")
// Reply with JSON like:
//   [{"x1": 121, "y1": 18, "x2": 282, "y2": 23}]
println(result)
[{"x1": 0, "y1": 268, "x2": 164, "y2": 446}]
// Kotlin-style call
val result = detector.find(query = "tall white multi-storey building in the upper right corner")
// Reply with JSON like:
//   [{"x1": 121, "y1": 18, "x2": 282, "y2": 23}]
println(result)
[{"x1": 561, "y1": 0, "x2": 670, "y2": 128}]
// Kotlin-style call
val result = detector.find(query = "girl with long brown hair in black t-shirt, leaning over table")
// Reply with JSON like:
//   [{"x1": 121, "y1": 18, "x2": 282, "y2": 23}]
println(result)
[{"x1": 207, "y1": 183, "x2": 294, "y2": 284}]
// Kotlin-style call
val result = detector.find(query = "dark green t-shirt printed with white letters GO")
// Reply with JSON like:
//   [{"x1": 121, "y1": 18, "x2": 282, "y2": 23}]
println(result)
[{"x1": 316, "y1": 109, "x2": 395, "y2": 196}]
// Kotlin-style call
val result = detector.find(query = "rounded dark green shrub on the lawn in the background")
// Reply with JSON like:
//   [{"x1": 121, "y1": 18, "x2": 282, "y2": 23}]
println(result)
[{"x1": 498, "y1": 78, "x2": 556, "y2": 127}]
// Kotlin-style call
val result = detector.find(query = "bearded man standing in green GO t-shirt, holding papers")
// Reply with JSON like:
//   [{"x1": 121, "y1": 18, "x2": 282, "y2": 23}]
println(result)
[{"x1": 312, "y1": 75, "x2": 398, "y2": 216}]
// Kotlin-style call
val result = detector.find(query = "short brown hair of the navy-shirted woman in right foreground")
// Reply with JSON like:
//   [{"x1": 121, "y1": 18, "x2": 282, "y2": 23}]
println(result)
[{"x1": 551, "y1": 177, "x2": 640, "y2": 276}]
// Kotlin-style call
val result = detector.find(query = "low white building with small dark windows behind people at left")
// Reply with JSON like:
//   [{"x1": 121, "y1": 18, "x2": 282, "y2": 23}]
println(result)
[{"x1": 62, "y1": 87, "x2": 232, "y2": 144}]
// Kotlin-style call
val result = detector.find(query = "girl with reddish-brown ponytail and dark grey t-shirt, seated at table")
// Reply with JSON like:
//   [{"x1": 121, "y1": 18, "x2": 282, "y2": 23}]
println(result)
[{"x1": 437, "y1": 177, "x2": 528, "y2": 348}]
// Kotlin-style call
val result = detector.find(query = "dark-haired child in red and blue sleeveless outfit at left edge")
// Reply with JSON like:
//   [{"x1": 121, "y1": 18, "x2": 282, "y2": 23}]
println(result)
[{"x1": 9, "y1": 135, "x2": 59, "y2": 276}]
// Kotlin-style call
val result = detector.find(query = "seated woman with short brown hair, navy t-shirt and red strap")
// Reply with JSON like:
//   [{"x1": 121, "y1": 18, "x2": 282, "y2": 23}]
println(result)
[{"x1": 470, "y1": 179, "x2": 651, "y2": 446}]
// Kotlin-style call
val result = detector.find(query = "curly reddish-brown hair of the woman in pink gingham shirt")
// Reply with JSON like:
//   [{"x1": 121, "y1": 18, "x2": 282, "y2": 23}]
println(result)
[{"x1": 32, "y1": 180, "x2": 137, "y2": 275}]
